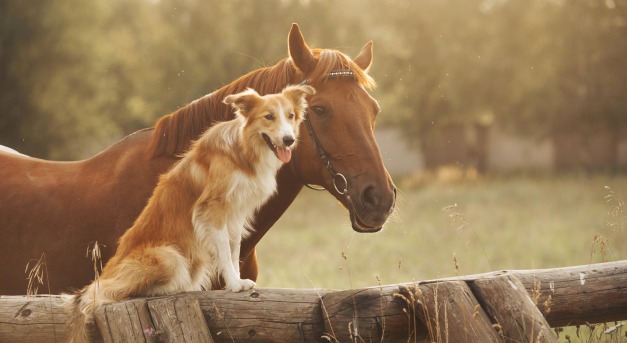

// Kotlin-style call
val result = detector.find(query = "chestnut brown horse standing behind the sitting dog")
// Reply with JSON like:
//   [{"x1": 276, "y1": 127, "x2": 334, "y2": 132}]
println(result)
[{"x1": 0, "y1": 24, "x2": 396, "y2": 294}]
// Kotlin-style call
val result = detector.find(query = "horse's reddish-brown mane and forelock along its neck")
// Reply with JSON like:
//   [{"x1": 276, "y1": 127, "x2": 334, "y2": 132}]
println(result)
[{"x1": 148, "y1": 49, "x2": 375, "y2": 157}]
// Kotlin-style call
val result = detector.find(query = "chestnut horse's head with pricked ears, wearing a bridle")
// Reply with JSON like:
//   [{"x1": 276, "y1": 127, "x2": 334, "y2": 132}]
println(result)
[{"x1": 288, "y1": 25, "x2": 396, "y2": 232}]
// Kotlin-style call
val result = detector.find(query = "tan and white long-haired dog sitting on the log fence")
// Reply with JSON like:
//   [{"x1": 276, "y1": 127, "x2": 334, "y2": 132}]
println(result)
[{"x1": 65, "y1": 85, "x2": 315, "y2": 342}]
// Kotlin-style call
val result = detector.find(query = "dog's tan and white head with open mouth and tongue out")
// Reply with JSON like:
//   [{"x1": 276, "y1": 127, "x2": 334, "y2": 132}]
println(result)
[{"x1": 224, "y1": 85, "x2": 315, "y2": 163}]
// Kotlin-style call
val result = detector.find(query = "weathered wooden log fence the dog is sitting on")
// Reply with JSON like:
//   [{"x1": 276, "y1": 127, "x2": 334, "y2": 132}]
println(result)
[{"x1": 0, "y1": 261, "x2": 627, "y2": 342}]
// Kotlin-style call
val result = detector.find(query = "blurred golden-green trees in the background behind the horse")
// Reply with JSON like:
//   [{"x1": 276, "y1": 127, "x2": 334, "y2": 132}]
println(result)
[{"x1": 0, "y1": 0, "x2": 627, "y2": 159}]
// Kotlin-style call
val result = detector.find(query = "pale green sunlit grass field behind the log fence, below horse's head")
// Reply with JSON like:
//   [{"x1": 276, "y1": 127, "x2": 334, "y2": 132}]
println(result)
[{"x1": 257, "y1": 175, "x2": 627, "y2": 289}]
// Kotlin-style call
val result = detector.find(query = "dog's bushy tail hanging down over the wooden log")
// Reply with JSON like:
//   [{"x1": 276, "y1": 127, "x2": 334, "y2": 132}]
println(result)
[{"x1": 63, "y1": 282, "x2": 103, "y2": 343}]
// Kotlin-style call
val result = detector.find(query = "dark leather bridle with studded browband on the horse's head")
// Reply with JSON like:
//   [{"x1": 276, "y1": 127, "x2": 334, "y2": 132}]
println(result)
[{"x1": 291, "y1": 70, "x2": 355, "y2": 196}]
